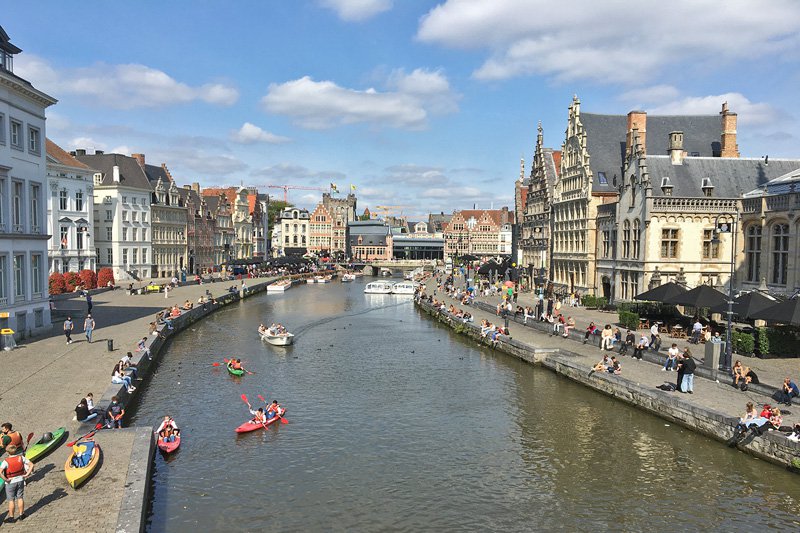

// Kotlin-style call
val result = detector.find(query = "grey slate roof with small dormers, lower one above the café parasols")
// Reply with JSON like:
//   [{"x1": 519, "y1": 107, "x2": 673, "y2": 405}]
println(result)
[{"x1": 647, "y1": 156, "x2": 800, "y2": 198}]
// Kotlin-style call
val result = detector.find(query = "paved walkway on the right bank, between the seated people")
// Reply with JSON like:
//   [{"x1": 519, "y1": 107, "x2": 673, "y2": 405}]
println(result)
[{"x1": 426, "y1": 279, "x2": 800, "y2": 425}]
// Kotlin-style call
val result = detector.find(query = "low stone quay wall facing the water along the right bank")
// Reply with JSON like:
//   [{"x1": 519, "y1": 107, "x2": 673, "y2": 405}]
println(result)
[{"x1": 415, "y1": 300, "x2": 800, "y2": 472}]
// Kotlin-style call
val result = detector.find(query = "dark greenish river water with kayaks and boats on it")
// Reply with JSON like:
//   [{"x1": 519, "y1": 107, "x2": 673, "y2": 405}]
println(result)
[{"x1": 134, "y1": 282, "x2": 800, "y2": 531}]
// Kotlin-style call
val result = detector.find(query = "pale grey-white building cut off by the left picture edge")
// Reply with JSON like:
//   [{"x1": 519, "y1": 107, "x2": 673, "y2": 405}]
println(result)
[{"x1": 0, "y1": 27, "x2": 56, "y2": 339}]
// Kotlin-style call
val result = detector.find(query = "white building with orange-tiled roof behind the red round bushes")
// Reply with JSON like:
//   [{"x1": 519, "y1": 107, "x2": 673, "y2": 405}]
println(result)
[{"x1": 47, "y1": 139, "x2": 97, "y2": 273}]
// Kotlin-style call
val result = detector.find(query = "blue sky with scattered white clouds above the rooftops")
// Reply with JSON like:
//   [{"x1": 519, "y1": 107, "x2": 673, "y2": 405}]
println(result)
[{"x1": 6, "y1": 0, "x2": 800, "y2": 218}]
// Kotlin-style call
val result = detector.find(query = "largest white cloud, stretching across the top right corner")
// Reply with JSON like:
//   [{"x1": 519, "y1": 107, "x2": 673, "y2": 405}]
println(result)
[{"x1": 417, "y1": 0, "x2": 800, "y2": 83}]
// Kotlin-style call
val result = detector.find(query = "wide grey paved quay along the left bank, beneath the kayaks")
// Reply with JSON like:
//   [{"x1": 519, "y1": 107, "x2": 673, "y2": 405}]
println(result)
[{"x1": 0, "y1": 280, "x2": 258, "y2": 532}]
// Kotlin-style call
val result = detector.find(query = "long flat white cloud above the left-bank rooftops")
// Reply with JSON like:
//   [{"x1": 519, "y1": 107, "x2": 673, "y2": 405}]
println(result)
[{"x1": 16, "y1": 54, "x2": 239, "y2": 109}]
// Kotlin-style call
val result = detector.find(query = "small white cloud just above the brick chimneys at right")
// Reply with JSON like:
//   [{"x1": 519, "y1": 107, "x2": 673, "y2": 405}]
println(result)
[{"x1": 647, "y1": 93, "x2": 783, "y2": 127}]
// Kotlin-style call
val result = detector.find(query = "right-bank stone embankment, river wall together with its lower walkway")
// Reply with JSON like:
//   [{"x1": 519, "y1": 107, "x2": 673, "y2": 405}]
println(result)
[{"x1": 415, "y1": 300, "x2": 800, "y2": 472}]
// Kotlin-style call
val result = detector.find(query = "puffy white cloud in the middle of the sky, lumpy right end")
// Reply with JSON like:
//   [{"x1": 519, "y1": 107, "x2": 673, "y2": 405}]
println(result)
[{"x1": 261, "y1": 69, "x2": 458, "y2": 129}]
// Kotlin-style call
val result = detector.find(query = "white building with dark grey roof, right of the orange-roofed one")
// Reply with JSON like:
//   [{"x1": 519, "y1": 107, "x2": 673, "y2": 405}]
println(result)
[{"x1": 75, "y1": 150, "x2": 153, "y2": 281}]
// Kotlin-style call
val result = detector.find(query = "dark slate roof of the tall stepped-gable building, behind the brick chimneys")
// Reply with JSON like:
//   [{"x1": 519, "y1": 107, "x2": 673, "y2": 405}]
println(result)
[{"x1": 580, "y1": 112, "x2": 722, "y2": 192}]
